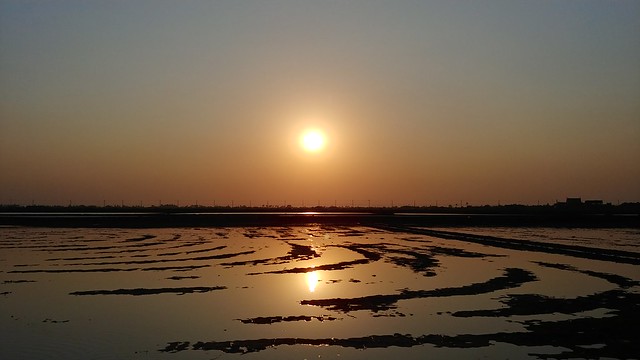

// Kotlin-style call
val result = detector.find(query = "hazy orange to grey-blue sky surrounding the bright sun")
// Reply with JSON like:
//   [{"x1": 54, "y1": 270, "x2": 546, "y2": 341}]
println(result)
[{"x1": 0, "y1": 0, "x2": 640, "y2": 206}]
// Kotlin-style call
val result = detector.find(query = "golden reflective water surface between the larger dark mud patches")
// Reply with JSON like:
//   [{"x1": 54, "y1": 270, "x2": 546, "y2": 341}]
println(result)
[{"x1": 0, "y1": 227, "x2": 640, "y2": 359}]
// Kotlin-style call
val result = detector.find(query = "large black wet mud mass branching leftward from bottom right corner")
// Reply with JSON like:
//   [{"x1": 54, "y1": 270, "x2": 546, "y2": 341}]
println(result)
[{"x1": 159, "y1": 290, "x2": 640, "y2": 359}]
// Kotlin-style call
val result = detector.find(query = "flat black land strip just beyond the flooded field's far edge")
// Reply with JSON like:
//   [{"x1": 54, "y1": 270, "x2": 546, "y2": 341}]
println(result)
[{"x1": 0, "y1": 212, "x2": 640, "y2": 228}]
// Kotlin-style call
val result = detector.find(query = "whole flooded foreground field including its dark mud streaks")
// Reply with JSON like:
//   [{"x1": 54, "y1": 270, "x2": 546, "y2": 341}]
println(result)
[{"x1": 0, "y1": 226, "x2": 640, "y2": 359}]
